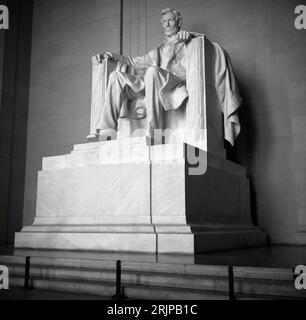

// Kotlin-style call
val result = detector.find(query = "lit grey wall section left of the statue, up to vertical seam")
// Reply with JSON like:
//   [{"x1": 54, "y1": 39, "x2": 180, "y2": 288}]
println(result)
[{"x1": 24, "y1": 0, "x2": 120, "y2": 225}]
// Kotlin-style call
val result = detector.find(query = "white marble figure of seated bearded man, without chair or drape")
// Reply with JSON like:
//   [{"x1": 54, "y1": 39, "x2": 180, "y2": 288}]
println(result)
[{"x1": 93, "y1": 8, "x2": 194, "y2": 139}]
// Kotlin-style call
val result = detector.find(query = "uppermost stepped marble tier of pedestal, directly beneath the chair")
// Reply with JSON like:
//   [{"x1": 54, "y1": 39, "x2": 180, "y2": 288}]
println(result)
[{"x1": 42, "y1": 138, "x2": 246, "y2": 177}]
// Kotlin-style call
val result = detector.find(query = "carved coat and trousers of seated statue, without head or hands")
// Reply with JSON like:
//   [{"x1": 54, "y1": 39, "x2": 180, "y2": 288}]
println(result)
[{"x1": 99, "y1": 42, "x2": 188, "y2": 137}]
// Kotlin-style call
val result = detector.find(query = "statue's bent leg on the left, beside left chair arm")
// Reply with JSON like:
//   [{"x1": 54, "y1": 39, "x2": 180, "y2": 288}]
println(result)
[{"x1": 98, "y1": 71, "x2": 144, "y2": 135}]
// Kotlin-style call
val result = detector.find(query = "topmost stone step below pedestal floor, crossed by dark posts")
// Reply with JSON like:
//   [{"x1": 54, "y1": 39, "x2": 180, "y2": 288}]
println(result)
[{"x1": 0, "y1": 255, "x2": 292, "y2": 281}]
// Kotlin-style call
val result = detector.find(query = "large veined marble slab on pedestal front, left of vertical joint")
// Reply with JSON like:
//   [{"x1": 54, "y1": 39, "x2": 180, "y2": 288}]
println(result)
[{"x1": 36, "y1": 163, "x2": 150, "y2": 219}]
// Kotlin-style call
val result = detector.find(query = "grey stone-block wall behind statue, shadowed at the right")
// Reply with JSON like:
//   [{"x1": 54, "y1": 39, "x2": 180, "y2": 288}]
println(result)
[{"x1": 24, "y1": 0, "x2": 306, "y2": 243}]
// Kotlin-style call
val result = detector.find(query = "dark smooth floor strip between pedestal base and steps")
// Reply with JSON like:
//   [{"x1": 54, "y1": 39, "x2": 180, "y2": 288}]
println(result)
[{"x1": 0, "y1": 245, "x2": 306, "y2": 268}]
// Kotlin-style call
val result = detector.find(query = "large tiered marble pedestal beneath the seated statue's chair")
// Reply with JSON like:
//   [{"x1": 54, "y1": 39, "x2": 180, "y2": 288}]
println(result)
[{"x1": 15, "y1": 138, "x2": 266, "y2": 254}]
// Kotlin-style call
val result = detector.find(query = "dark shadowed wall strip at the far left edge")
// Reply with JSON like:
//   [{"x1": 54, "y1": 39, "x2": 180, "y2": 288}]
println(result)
[{"x1": 0, "y1": 0, "x2": 32, "y2": 245}]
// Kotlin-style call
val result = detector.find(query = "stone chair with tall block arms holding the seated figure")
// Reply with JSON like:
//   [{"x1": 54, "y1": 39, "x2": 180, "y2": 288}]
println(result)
[{"x1": 87, "y1": 34, "x2": 225, "y2": 157}]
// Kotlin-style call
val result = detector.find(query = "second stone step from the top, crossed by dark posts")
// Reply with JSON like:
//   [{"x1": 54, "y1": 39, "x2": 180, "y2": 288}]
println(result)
[{"x1": 11, "y1": 267, "x2": 299, "y2": 297}]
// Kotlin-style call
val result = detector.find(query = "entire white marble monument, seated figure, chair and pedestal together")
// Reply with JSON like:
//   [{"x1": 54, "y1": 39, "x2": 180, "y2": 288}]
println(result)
[{"x1": 15, "y1": 9, "x2": 266, "y2": 257}]
